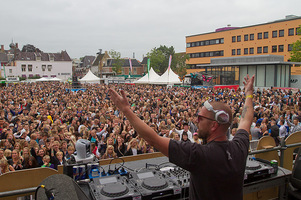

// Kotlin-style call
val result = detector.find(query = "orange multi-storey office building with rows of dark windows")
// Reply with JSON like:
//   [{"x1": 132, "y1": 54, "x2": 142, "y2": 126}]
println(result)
[{"x1": 186, "y1": 15, "x2": 301, "y2": 85}]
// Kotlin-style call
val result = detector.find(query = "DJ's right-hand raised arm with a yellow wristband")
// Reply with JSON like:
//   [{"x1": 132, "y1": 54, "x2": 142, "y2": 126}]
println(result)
[{"x1": 238, "y1": 75, "x2": 255, "y2": 133}]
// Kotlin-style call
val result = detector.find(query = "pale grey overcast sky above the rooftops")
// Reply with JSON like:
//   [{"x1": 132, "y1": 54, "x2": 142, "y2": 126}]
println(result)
[{"x1": 0, "y1": 0, "x2": 301, "y2": 61}]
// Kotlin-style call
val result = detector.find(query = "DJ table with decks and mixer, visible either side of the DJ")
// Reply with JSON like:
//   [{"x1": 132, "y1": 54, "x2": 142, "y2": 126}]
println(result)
[{"x1": 56, "y1": 156, "x2": 291, "y2": 200}]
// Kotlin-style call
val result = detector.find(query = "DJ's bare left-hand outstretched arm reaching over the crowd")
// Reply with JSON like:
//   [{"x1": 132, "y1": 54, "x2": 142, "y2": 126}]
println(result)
[{"x1": 109, "y1": 89, "x2": 170, "y2": 156}]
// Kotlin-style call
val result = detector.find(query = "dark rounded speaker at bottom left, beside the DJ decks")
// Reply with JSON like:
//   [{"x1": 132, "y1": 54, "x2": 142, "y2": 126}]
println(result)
[{"x1": 36, "y1": 174, "x2": 90, "y2": 200}]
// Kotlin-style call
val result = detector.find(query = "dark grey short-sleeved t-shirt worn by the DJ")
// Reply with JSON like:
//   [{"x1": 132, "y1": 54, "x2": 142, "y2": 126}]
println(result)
[{"x1": 169, "y1": 129, "x2": 249, "y2": 200}]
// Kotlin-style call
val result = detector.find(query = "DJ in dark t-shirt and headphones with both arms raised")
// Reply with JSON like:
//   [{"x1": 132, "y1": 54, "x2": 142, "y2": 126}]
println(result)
[{"x1": 110, "y1": 75, "x2": 254, "y2": 200}]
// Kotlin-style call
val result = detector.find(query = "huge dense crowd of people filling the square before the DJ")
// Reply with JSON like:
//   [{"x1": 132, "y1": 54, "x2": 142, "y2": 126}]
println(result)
[{"x1": 0, "y1": 82, "x2": 301, "y2": 175}]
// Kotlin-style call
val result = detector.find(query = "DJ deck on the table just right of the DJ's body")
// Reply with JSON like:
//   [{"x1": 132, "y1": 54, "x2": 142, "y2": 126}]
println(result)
[{"x1": 244, "y1": 157, "x2": 275, "y2": 183}]
